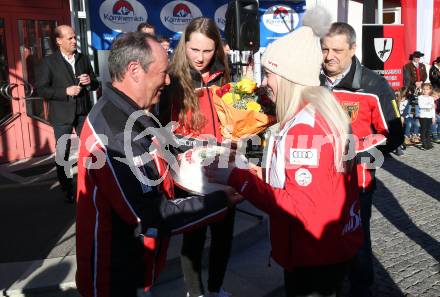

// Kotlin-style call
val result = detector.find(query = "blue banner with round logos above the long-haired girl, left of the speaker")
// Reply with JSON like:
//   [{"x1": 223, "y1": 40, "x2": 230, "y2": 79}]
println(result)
[{"x1": 89, "y1": 0, "x2": 229, "y2": 50}]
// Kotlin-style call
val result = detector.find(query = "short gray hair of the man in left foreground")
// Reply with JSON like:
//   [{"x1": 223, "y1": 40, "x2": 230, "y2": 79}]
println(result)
[{"x1": 108, "y1": 32, "x2": 156, "y2": 81}]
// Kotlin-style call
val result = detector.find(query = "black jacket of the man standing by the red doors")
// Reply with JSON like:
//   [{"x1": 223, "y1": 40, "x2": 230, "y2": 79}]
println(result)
[{"x1": 35, "y1": 50, "x2": 99, "y2": 125}]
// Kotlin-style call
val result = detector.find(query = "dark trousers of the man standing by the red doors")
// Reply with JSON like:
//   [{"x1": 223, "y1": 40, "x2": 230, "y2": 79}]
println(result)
[{"x1": 53, "y1": 115, "x2": 87, "y2": 191}]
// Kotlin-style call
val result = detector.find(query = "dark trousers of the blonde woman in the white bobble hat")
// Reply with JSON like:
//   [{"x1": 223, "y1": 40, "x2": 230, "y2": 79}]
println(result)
[{"x1": 284, "y1": 262, "x2": 349, "y2": 297}]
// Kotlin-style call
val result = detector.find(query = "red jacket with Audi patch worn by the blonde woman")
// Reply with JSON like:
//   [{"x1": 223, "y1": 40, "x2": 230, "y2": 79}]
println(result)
[{"x1": 229, "y1": 107, "x2": 362, "y2": 269}]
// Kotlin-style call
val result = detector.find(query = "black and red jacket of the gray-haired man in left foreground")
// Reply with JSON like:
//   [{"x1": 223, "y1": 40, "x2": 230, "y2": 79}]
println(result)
[{"x1": 76, "y1": 85, "x2": 227, "y2": 297}]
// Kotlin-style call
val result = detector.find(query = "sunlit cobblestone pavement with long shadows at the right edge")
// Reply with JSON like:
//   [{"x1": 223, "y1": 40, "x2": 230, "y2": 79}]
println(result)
[{"x1": 371, "y1": 145, "x2": 440, "y2": 297}]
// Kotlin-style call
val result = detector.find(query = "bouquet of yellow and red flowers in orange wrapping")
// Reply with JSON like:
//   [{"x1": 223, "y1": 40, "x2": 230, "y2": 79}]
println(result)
[{"x1": 213, "y1": 78, "x2": 275, "y2": 139}]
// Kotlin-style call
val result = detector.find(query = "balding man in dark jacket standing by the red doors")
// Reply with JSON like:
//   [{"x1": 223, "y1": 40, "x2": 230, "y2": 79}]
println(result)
[{"x1": 35, "y1": 25, "x2": 99, "y2": 203}]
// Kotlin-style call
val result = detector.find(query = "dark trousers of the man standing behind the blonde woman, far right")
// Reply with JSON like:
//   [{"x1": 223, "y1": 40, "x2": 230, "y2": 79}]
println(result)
[{"x1": 349, "y1": 191, "x2": 374, "y2": 297}]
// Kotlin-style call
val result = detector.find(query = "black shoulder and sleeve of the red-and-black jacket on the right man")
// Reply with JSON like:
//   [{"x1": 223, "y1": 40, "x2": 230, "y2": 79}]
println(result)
[{"x1": 320, "y1": 57, "x2": 403, "y2": 153}]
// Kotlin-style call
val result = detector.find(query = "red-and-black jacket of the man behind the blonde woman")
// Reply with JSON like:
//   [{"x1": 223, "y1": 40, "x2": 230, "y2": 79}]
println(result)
[{"x1": 320, "y1": 56, "x2": 403, "y2": 192}]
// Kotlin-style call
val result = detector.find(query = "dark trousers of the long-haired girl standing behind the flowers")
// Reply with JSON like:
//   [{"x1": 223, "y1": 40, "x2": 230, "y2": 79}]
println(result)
[{"x1": 180, "y1": 209, "x2": 235, "y2": 297}]
